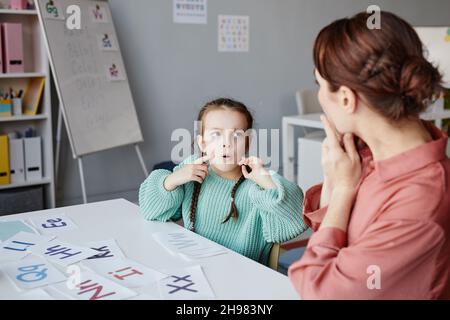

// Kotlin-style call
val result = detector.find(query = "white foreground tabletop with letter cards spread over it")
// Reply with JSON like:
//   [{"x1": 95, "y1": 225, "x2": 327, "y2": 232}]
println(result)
[{"x1": 0, "y1": 199, "x2": 298, "y2": 300}]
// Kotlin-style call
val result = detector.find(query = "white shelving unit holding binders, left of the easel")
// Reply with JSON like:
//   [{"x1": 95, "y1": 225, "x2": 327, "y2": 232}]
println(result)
[{"x1": 0, "y1": 9, "x2": 55, "y2": 208}]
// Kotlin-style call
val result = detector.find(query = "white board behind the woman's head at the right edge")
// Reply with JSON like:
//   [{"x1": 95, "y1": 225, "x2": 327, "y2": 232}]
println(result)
[{"x1": 414, "y1": 27, "x2": 450, "y2": 88}]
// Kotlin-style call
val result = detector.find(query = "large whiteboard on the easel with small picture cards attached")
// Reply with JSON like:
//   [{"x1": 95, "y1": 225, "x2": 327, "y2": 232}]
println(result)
[{"x1": 36, "y1": 0, "x2": 143, "y2": 157}]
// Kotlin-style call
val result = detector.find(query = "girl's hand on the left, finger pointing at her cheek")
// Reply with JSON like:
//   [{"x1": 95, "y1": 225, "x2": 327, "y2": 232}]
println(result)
[{"x1": 164, "y1": 155, "x2": 213, "y2": 191}]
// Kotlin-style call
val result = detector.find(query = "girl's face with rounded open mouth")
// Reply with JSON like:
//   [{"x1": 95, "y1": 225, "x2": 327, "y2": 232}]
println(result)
[{"x1": 198, "y1": 109, "x2": 248, "y2": 172}]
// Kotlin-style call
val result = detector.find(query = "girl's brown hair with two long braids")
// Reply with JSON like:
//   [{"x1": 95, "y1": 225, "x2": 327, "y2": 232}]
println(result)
[{"x1": 189, "y1": 98, "x2": 253, "y2": 232}]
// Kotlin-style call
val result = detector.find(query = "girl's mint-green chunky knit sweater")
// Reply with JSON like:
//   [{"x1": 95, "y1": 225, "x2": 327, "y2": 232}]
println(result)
[{"x1": 139, "y1": 156, "x2": 307, "y2": 264}]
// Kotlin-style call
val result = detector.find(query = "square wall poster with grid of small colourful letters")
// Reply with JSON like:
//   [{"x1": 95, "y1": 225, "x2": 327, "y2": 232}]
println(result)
[{"x1": 218, "y1": 15, "x2": 250, "y2": 52}]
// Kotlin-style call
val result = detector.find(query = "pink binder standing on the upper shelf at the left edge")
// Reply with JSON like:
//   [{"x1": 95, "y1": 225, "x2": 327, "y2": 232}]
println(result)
[{"x1": 2, "y1": 22, "x2": 25, "y2": 73}]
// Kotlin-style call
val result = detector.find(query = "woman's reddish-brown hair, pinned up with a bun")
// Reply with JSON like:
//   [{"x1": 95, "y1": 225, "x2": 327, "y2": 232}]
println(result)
[{"x1": 313, "y1": 11, "x2": 442, "y2": 120}]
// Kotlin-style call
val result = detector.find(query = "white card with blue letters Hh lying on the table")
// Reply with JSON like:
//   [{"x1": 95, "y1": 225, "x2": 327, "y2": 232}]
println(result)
[{"x1": 29, "y1": 240, "x2": 98, "y2": 266}]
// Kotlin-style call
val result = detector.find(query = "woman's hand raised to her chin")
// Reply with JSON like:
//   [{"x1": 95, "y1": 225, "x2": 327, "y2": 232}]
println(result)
[{"x1": 321, "y1": 116, "x2": 362, "y2": 195}]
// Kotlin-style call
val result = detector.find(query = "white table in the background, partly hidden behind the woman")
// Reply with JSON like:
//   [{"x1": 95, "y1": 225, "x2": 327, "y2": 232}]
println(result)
[{"x1": 281, "y1": 104, "x2": 450, "y2": 182}]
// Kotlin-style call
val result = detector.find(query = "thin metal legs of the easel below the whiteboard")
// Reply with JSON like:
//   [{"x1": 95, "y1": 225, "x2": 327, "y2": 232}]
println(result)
[{"x1": 55, "y1": 106, "x2": 148, "y2": 204}]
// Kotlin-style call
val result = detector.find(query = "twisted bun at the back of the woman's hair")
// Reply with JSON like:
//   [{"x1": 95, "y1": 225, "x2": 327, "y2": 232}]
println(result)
[{"x1": 399, "y1": 56, "x2": 442, "y2": 115}]
